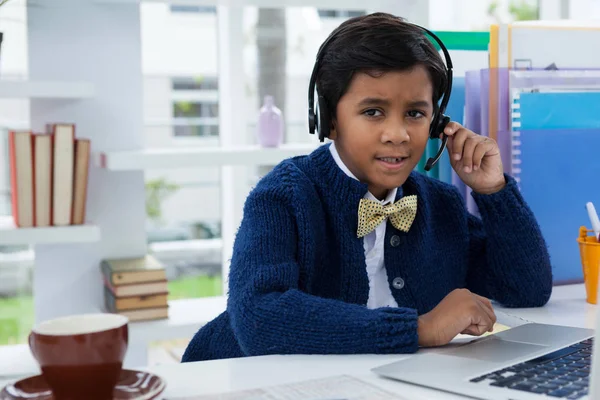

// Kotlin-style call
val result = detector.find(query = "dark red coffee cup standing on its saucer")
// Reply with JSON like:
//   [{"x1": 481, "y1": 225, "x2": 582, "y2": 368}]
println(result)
[{"x1": 29, "y1": 314, "x2": 129, "y2": 400}]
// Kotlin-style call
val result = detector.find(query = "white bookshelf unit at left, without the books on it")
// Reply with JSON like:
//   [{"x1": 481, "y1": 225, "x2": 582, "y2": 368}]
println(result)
[{"x1": 22, "y1": 0, "x2": 147, "y2": 367}]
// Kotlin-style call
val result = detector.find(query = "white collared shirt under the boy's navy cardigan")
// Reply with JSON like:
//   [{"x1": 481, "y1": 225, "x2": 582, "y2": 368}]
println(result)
[{"x1": 329, "y1": 142, "x2": 398, "y2": 309}]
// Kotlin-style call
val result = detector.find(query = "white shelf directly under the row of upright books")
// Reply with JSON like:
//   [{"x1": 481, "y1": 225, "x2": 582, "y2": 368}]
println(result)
[{"x1": 0, "y1": 217, "x2": 100, "y2": 246}]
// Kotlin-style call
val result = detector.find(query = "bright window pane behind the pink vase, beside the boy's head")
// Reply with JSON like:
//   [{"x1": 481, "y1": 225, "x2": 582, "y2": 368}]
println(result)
[{"x1": 244, "y1": 7, "x2": 365, "y2": 143}]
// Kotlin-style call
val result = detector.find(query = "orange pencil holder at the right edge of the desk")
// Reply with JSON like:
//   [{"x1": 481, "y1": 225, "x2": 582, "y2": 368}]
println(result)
[{"x1": 577, "y1": 226, "x2": 600, "y2": 304}]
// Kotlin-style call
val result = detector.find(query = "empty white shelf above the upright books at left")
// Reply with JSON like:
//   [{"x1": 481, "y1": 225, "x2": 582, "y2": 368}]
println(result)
[{"x1": 0, "y1": 80, "x2": 94, "y2": 99}]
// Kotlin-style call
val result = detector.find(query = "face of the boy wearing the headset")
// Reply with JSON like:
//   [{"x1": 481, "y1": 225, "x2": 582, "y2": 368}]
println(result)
[{"x1": 329, "y1": 65, "x2": 433, "y2": 199}]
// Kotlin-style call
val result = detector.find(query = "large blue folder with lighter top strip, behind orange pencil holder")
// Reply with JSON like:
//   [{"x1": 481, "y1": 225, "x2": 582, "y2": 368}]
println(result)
[{"x1": 513, "y1": 92, "x2": 600, "y2": 283}]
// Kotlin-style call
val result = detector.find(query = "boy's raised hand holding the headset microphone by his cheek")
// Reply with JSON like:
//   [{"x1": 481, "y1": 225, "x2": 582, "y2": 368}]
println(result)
[{"x1": 444, "y1": 121, "x2": 506, "y2": 194}]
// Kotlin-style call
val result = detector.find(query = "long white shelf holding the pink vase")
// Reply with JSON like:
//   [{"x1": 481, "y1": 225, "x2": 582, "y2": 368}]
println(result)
[{"x1": 94, "y1": 143, "x2": 320, "y2": 171}]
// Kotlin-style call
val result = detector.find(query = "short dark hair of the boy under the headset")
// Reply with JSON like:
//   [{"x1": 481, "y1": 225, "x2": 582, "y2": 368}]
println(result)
[{"x1": 316, "y1": 13, "x2": 448, "y2": 118}]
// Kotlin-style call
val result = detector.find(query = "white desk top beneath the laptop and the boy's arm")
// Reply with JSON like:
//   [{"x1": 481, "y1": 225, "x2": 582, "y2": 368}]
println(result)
[{"x1": 149, "y1": 285, "x2": 596, "y2": 400}]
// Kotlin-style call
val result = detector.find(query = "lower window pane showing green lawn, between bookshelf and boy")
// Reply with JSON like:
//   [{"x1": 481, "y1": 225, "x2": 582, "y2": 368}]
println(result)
[{"x1": 146, "y1": 168, "x2": 222, "y2": 300}]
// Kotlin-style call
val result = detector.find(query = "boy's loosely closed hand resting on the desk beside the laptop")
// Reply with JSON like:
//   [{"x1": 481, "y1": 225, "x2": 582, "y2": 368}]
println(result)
[{"x1": 417, "y1": 289, "x2": 496, "y2": 347}]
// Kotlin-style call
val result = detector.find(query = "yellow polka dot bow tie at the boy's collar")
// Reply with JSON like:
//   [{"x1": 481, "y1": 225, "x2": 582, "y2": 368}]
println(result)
[{"x1": 357, "y1": 195, "x2": 417, "y2": 238}]
